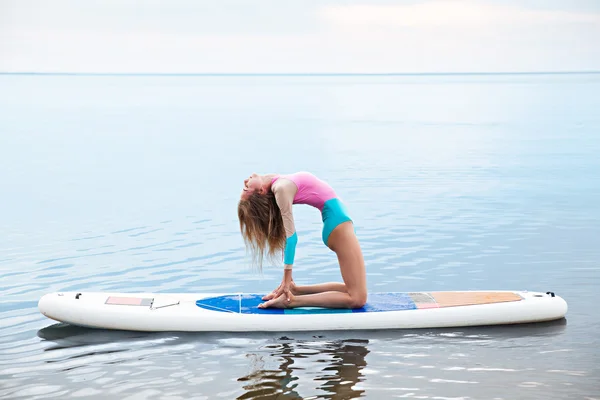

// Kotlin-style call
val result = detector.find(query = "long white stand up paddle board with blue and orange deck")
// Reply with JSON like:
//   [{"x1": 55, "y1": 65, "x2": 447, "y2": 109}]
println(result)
[{"x1": 38, "y1": 291, "x2": 567, "y2": 332}]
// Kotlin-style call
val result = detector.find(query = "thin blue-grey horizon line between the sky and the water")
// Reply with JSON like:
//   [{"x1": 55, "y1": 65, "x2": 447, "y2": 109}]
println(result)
[{"x1": 0, "y1": 70, "x2": 600, "y2": 76}]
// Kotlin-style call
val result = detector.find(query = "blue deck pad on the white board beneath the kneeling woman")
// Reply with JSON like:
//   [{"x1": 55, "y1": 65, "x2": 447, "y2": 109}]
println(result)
[{"x1": 196, "y1": 293, "x2": 417, "y2": 315}]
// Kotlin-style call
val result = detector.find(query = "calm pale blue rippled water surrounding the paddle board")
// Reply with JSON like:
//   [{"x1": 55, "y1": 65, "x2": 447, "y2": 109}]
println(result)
[{"x1": 0, "y1": 74, "x2": 600, "y2": 399}]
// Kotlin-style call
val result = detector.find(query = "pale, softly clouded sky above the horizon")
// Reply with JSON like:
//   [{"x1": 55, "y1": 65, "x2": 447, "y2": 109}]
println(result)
[{"x1": 0, "y1": 0, "x2": 600, "y2": 73}]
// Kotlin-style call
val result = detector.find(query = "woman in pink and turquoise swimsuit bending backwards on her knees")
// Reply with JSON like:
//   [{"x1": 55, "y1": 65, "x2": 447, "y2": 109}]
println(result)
[{"x1": 238, "y1": 172, "x2": 367, "y2": 308}]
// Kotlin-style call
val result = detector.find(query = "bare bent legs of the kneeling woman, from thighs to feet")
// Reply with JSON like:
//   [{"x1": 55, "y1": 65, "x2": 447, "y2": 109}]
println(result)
[{"x1": 261, "y1": 222, "x2": 367, "y2": 308}]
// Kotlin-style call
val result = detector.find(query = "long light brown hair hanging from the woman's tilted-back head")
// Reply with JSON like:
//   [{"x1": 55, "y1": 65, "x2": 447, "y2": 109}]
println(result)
[{"x1": 238, "y1": 191, "x2": 286, "y2": 272}]
